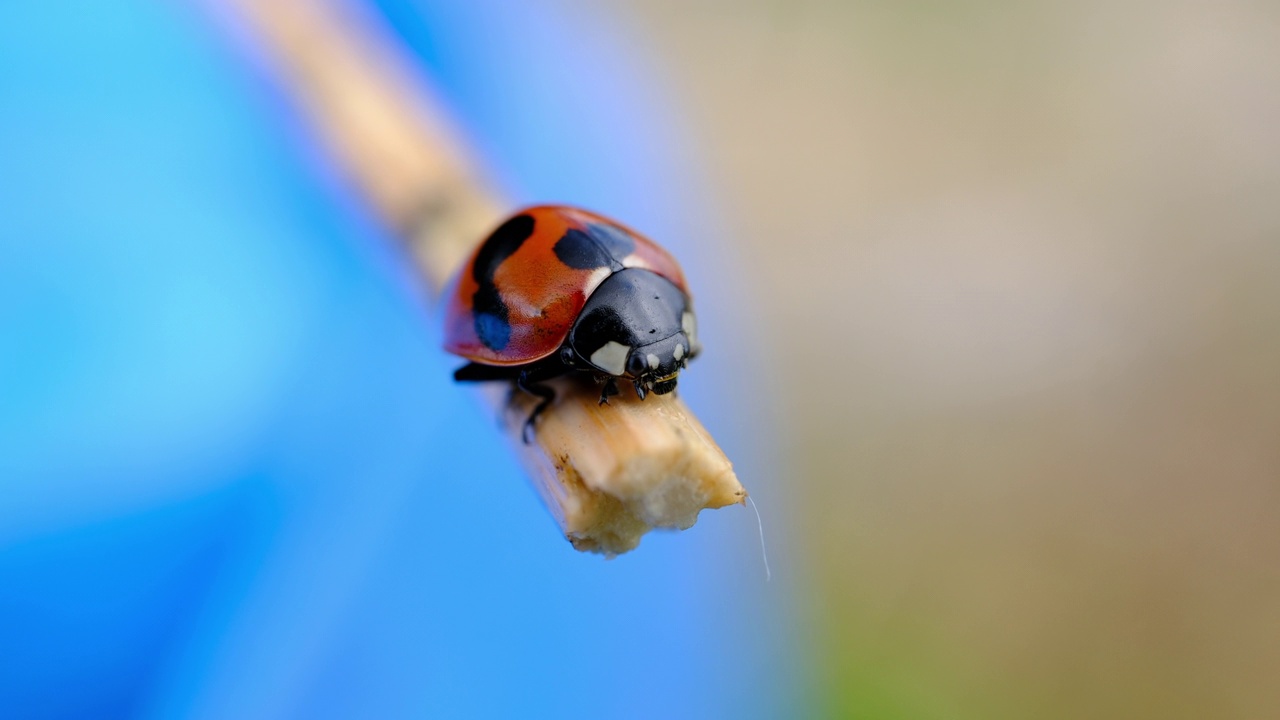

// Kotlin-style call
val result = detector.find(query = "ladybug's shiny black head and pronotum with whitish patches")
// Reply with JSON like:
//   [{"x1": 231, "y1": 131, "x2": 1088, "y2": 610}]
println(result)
[{"x1": 570, "y1": 268, "x2": 698, "y2": 398}]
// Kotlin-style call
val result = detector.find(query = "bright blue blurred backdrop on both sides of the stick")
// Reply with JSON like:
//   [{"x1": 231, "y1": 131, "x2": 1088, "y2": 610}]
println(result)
[{"x1": 0, "y1": 0, "x2": 804, "y2": 719}]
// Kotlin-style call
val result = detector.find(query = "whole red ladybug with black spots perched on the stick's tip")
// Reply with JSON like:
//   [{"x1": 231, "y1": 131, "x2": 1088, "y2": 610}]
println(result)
[{"x1": 444, "y1": 205, "x2": 699, "y2": 441}]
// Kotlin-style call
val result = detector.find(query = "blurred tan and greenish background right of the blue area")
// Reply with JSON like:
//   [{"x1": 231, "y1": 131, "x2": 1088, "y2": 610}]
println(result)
[{"x1": 623, "y1": 0, "x2": 1280, "y2": 717}]
